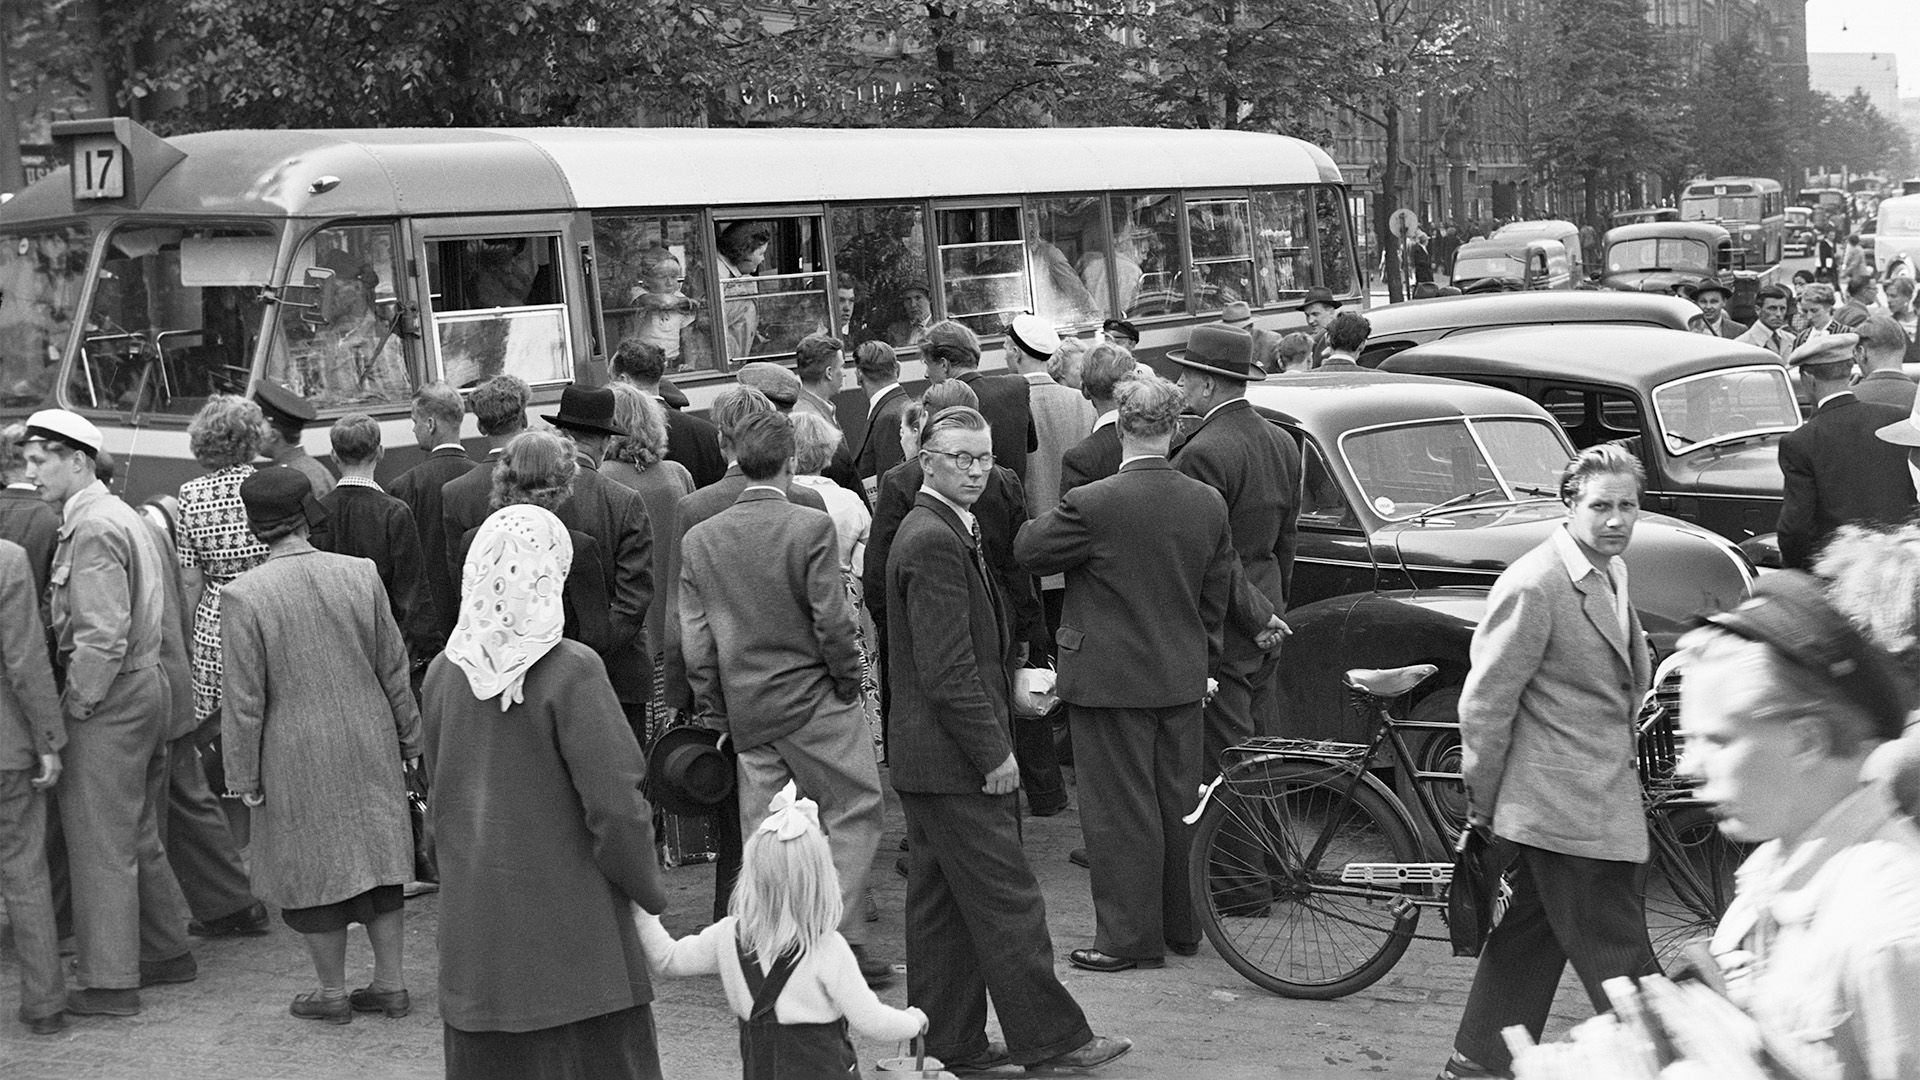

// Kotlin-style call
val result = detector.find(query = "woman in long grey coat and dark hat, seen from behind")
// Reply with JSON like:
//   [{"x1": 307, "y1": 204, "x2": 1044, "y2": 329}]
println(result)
[{"x1": 221, "y1": 469, "x2": 420, "y2": 1024}]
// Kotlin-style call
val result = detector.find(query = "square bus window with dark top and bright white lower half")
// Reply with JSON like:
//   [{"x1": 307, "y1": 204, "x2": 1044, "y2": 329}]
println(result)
[{"x1": 426, "y1": 234, "x2": 574, "y2": 386}]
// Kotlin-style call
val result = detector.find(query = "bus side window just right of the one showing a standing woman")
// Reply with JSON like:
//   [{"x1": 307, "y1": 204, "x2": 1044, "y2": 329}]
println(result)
[{"x1": 829, "y1": 202, "x2": 935, "y2": 352}]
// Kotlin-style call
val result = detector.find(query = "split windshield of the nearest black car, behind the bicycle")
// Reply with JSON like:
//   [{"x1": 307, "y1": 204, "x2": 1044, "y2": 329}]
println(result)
[{"x1": 1340, "y1": 417, "x2": 1572, "y2": 521}]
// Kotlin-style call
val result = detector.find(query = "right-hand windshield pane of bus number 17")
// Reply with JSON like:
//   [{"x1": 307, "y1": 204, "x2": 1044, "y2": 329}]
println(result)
[{"x1": 67, "y1": 221, "x2": 278, "y2": 415}]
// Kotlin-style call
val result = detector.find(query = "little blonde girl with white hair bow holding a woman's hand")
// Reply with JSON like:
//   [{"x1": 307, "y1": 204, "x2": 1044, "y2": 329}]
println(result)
[{"x1": 634, "y1": 780, "x2": 927, "y2": 1080}]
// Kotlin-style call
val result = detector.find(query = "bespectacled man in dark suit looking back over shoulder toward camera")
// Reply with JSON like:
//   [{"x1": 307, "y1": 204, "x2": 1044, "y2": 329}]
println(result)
[{"x1": 887, "y1": 407, "x2": 1131, "y2": 1070}]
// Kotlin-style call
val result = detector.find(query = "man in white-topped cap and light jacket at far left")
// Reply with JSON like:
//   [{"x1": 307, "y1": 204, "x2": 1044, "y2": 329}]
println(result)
[{"x1": 25, "y1": 409, "x2": 194, "y2": 1017}]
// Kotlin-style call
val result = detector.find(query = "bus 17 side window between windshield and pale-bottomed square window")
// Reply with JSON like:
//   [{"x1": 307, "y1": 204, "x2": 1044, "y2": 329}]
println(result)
[{"x1": 267, "y1": 223, "x2": 417, "y2": 409}]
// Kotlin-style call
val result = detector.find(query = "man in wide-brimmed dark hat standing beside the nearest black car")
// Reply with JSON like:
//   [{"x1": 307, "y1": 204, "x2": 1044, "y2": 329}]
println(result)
[{"x1": 1169, "y1": 327, "x2": 1300, "y2": 757}]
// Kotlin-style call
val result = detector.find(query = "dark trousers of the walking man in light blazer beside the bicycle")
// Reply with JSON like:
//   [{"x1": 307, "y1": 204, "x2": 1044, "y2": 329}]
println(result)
[{"x1": 1453, "y1": 844, "x2": 1661, "y2": 1072}]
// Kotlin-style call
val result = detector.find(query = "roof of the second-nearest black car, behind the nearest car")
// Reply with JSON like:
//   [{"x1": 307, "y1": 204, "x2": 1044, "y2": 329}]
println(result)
[{"x1": 1382, "y1": 325, "x2": 1786, "y2": 388}]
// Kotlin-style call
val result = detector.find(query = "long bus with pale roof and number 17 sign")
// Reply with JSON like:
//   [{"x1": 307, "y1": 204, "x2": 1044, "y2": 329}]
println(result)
[{"x1": 0, "y1": 119, "x2": 1365, "y2": 496}]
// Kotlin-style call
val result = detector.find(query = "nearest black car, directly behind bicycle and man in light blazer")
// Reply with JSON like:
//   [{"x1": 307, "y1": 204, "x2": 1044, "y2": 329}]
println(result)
[{"x1": 1248, "y1": 371, "x2": 1753, "y2": 745}]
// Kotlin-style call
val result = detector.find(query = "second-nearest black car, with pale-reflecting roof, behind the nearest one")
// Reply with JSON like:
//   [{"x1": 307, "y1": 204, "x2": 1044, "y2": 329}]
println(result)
[{"x1": 1384, "y1": 327, "x2": 1799, "y2": 544}]
